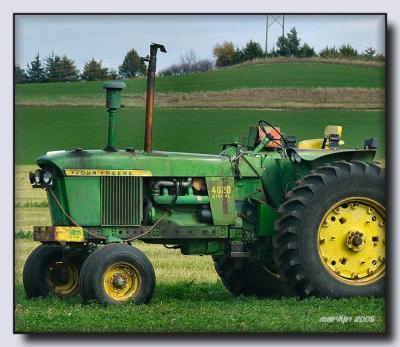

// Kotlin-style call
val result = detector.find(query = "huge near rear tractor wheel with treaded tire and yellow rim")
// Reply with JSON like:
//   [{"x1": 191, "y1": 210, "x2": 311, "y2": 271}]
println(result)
[{"x1": 273, "y1": 161, "x2": 386, "y2": 298}]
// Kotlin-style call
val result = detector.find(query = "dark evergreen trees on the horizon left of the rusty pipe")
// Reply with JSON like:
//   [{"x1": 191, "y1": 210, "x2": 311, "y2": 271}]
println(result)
[{"x1": 15, "y1": 49, "x2": 146, "y2": 83}]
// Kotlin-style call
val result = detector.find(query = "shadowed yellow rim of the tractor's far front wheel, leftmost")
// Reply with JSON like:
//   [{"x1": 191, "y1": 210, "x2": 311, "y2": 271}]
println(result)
[{"x1": 46, "y1": 261, "x2": 79, "y2": 297}]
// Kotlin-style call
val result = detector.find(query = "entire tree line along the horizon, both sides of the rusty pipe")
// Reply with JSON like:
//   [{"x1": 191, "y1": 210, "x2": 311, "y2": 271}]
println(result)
[{"x1": 15, "y1": 28, "x2": 384, "y2": 83}]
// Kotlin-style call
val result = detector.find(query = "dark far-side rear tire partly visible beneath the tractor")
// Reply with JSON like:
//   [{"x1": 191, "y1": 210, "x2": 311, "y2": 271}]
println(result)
[{"x1": 213, "y1": 254, "x2": 289, "y2": 297}]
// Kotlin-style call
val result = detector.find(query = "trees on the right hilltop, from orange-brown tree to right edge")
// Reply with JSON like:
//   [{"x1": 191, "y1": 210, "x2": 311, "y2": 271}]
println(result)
[{"x1": 213, "y1": 28, "x2": 384, "y2": 67}]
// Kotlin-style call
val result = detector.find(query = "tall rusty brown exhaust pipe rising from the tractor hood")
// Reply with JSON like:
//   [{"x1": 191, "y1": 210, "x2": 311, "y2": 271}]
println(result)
[{"x1": 142, "y1": 43, "x2": 167, "y2": 152}]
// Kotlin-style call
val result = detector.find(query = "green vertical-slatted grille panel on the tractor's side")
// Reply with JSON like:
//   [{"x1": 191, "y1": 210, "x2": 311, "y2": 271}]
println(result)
[{"x1": 100, "y1": 176, "x2": 143, "y2": 226}]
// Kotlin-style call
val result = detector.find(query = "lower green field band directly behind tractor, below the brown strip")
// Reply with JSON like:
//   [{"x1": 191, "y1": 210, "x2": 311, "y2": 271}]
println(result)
[{"x1": 15, "y1": 106, "x2": 385, "y2": 164}]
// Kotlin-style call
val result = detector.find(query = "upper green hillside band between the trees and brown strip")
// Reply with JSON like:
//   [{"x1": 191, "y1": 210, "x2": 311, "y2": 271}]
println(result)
[{"x1": 16, "y1": 63, "x2": 385, "y2": 102}]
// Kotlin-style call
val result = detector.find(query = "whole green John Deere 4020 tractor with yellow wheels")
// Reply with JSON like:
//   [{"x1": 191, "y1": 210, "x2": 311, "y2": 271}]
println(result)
[{"x1": 23, "y1": 44, "x2": 385, "y2": 304}]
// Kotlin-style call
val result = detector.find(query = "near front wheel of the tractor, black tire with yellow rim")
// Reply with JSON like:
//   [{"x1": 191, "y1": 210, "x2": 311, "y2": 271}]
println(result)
[{"x1": 80, "y1": 244, "x2": 156, "y2": 305}]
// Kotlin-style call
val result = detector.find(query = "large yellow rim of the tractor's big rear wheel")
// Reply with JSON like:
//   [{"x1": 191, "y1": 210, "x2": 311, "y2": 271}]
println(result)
[{"x1": 317, "y1": 197, "x2": 385, "y2": 285}]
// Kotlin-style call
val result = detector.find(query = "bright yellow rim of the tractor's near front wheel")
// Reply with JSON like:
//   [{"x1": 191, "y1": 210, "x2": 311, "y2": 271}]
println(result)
[{"x1": 103, "y1": 262, "x2": 140, "y2": 301}]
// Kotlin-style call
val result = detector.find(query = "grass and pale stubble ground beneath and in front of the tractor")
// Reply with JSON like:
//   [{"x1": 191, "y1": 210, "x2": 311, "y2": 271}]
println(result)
[{"x1": 15, "y1": 240, "x2": 385, "y2": 333}]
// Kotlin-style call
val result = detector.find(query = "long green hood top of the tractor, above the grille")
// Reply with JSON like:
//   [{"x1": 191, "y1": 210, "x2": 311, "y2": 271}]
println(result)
[{"x1": 37, "y1": 149, "x2": 233, "y2": 177}]
